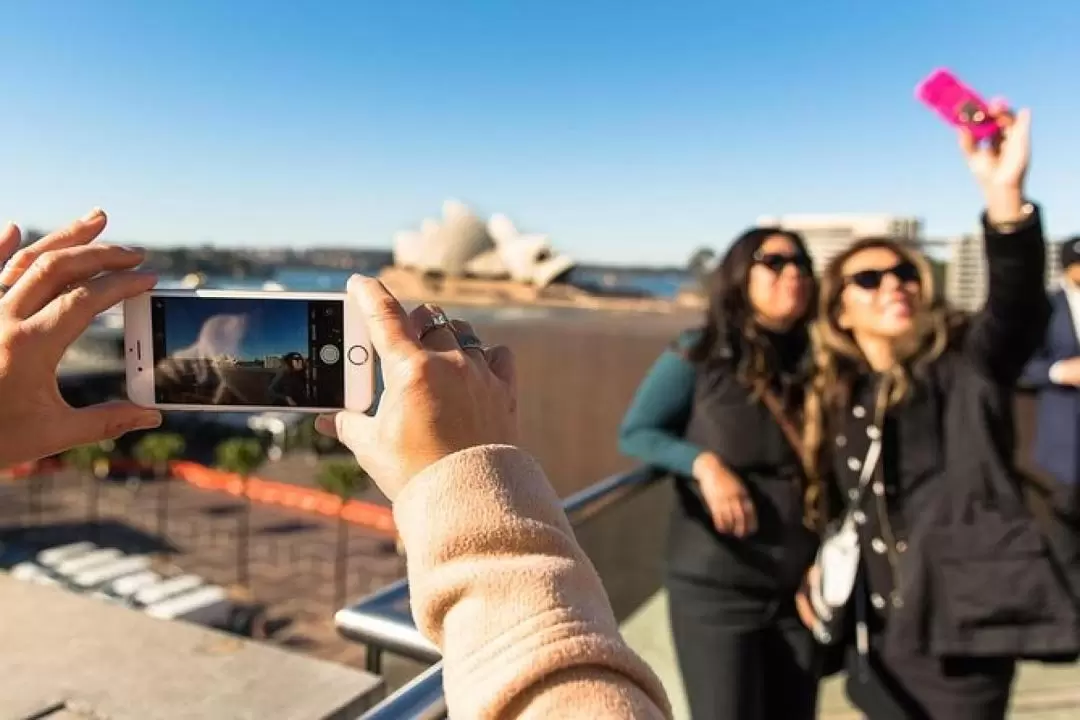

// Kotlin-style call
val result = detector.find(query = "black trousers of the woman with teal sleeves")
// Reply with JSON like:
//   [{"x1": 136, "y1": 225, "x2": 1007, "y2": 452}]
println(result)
[{"x1": 666, "y1": 574, "x2": 819, "y2": 720}]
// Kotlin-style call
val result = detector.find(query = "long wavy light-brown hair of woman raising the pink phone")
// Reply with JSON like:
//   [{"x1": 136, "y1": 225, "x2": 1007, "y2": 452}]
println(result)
[{"x1": 802, "y1": 237, "x2": 964, "y2": 529}]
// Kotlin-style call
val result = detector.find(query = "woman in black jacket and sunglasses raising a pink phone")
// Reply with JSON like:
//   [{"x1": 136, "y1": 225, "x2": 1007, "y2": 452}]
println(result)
[{"x1": 799, "y1": 104, "x2": 1080, "y2": 720}]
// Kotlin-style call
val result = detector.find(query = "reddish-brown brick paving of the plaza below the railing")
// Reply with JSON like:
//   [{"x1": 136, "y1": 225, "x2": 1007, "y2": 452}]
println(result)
[{"x1": 0, "y1": 471, "x2": 406, "y2": 682}]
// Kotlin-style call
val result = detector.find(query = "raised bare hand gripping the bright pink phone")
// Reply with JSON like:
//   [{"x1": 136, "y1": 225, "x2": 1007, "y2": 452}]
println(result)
[{"x1": 960, "y1": 103, "x2": 1031, "y2": 222}]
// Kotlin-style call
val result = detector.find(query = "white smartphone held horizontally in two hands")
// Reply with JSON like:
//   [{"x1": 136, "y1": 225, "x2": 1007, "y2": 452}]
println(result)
[{"x1": 124, "y1": 290, "x2": 376, "y2": 412}]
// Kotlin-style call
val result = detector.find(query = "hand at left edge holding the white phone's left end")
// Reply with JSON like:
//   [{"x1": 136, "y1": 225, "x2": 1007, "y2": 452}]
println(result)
[{"x1": 0, "y1": 210, "x2": 161, "y2": 466}]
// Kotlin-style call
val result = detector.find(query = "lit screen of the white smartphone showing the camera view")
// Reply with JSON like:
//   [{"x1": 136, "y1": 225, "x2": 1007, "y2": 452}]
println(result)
[{"x1": 150, "y1": 296, "x2": 346, "y2": 408}]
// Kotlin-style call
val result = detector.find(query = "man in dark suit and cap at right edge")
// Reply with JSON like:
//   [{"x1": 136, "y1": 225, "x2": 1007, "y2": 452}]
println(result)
[{"x1": 1022, "y1": 235, "x2": 1080, "y2": 510}]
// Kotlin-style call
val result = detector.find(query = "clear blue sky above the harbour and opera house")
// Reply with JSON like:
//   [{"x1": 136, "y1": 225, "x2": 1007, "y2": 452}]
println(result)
[{"x1": 0, "y1": 0, "x2": 1080, "y2": 263}]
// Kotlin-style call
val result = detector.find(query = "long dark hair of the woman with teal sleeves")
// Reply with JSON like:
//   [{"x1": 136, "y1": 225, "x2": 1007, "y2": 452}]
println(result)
[{"x1": 686, "y1": 227, "x2": 816, "y2": 394}]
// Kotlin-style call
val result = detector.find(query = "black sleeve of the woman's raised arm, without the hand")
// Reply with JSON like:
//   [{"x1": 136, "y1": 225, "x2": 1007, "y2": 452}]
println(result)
[{"x1": 964, "y1": 207, "x2": 1050, "y2": 386}]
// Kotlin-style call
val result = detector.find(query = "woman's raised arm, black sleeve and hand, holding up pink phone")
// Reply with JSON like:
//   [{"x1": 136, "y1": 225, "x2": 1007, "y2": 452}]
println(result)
[{"x1": 961, "y1": 108, "x2": 1050, "y2": 385}]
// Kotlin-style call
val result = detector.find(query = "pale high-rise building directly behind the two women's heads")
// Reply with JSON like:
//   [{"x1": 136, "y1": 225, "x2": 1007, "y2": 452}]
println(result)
[{"x1": 757, "y1": 214, "x2": 922, "y2": 272}]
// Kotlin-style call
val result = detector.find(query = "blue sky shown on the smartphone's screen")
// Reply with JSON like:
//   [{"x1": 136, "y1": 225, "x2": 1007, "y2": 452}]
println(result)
[{"x1": 164, "y1": 298, "x2": 309, "y2": 361}]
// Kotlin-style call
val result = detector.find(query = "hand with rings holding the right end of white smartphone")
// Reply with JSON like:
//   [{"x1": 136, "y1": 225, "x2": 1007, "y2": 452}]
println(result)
[{"x1": 315, "y1": 275, "x2": 517, "y2": 501}]
